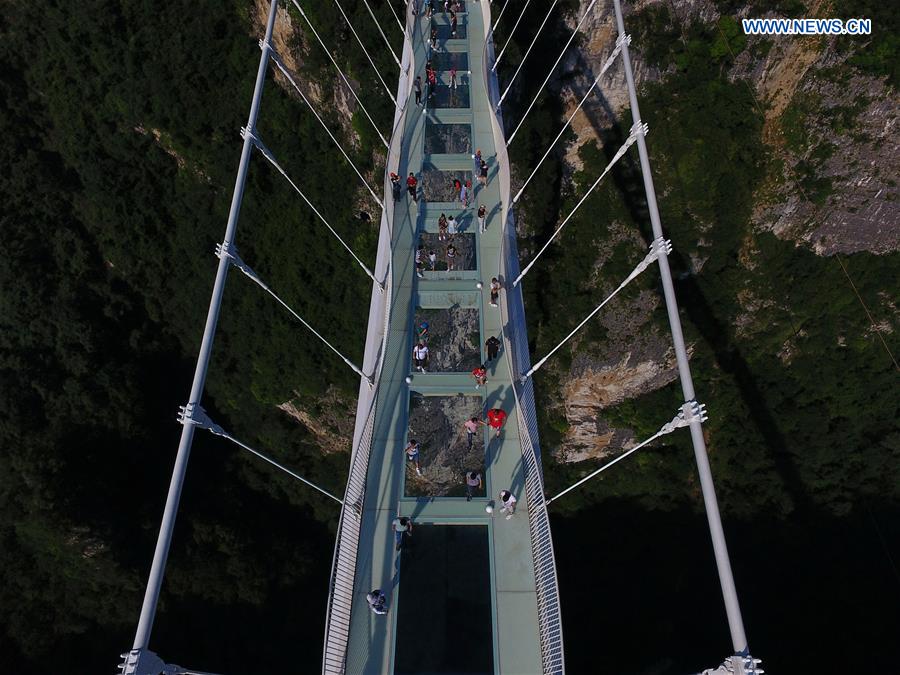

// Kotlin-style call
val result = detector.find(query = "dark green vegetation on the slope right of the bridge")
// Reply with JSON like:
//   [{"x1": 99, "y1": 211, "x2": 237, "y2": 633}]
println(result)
[{"x1": 496, "y1": 2, "x2": 900, "y2": 673}]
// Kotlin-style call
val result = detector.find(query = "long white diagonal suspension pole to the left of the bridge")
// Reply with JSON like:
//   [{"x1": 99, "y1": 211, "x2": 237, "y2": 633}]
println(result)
[{"x1": 133, "y1": 0, "x2": 278, "y2": 649}]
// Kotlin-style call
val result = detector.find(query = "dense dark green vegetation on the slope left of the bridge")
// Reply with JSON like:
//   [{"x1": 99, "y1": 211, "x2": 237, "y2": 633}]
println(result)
[{"x1": 0, "y1": 0, "x2": 401, "y2": 675}]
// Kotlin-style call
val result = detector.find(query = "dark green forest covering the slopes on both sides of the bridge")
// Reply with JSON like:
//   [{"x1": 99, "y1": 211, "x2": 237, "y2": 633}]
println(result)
[{"x1": 0, "y1": 0, "x2": 900, "y2": 675}]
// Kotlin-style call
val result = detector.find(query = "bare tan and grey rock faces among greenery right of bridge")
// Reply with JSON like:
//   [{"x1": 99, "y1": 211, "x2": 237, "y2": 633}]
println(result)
[{"x1": 528, "y1": 0, "x2": 900, "y2": 462}]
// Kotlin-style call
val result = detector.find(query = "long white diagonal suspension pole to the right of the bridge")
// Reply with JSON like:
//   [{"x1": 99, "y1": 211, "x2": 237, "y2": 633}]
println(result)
[{"x1": 613, "y1": 0, "x2": 747, "y2": 654}]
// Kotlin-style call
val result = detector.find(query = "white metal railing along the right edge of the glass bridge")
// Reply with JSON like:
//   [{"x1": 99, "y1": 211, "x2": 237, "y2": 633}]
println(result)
[{"x1": 480, "y1": 2, "x2": 565, "y2": 675}]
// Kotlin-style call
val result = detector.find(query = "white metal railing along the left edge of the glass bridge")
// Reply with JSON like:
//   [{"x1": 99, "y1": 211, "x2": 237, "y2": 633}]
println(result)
[{"x1": 322, "y1": 3, "x2": 415, "y2": 675}]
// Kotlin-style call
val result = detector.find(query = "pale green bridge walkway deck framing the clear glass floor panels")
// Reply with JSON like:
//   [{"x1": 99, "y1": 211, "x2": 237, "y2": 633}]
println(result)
[{"x1": 346, "y1": 0, "x2": 542, "y2": 673}]
